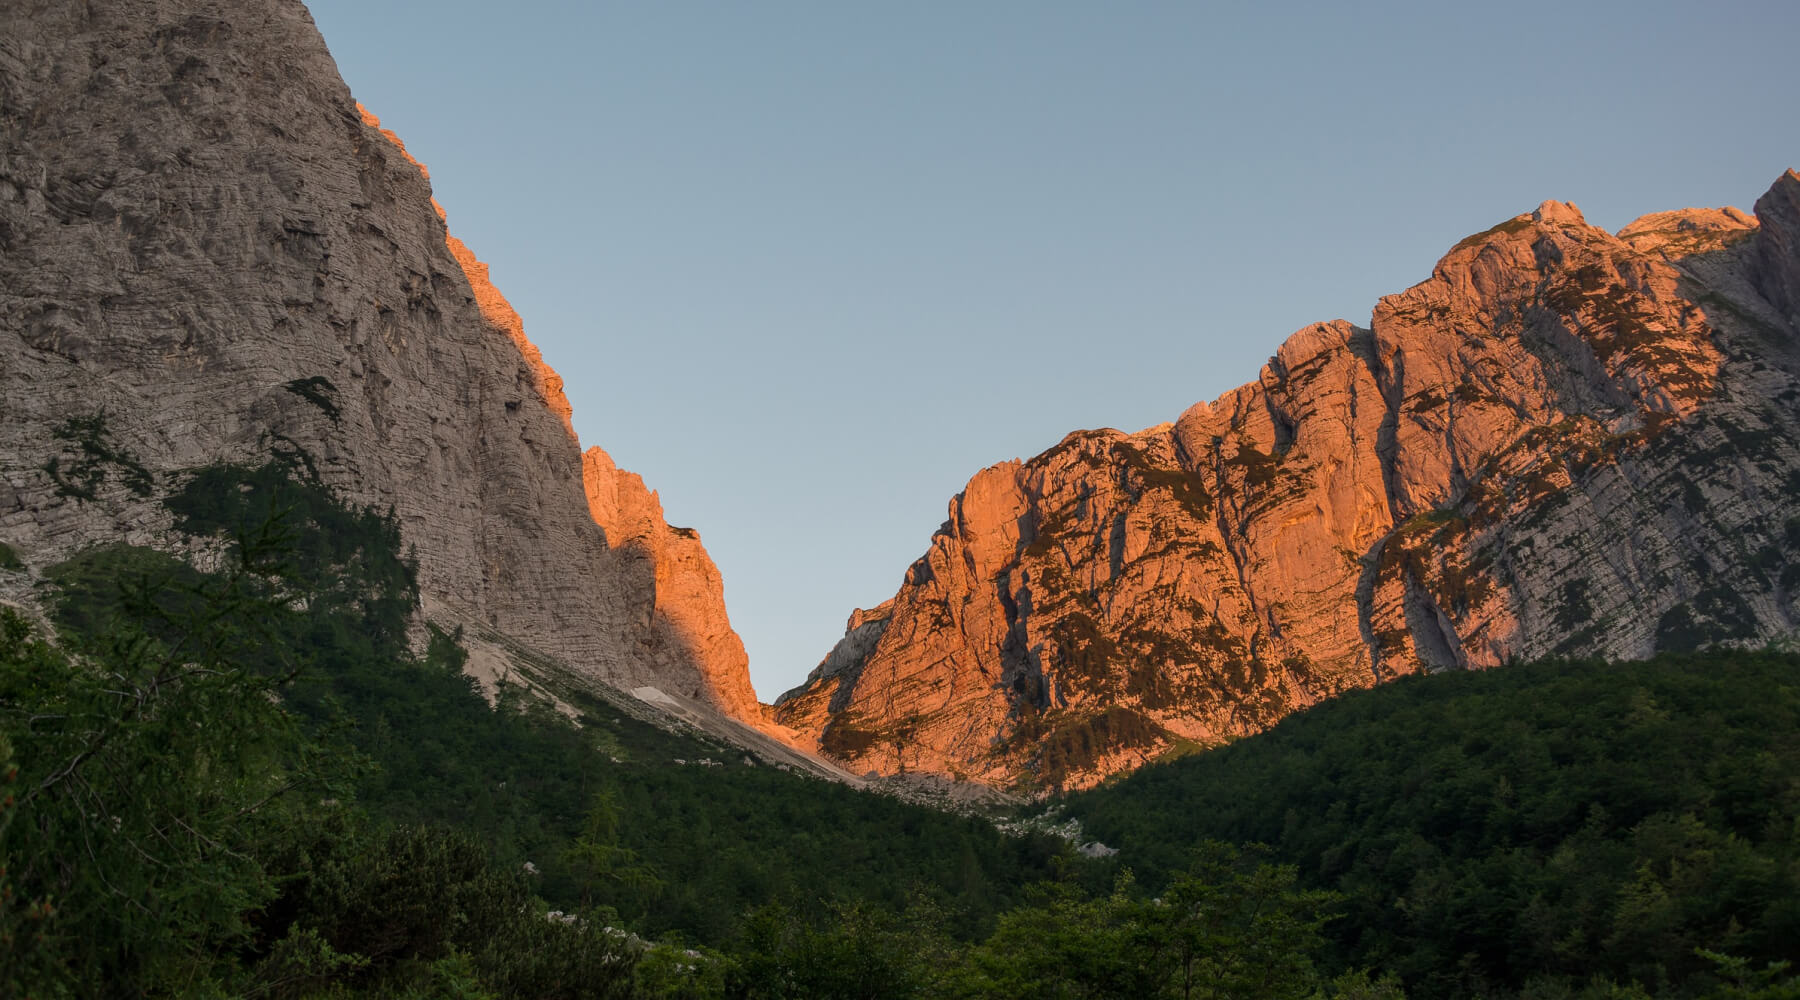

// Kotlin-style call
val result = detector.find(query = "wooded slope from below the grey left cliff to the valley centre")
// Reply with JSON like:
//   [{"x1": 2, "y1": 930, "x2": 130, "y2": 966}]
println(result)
[{"x1": 10, "y1": 447, "x2": 1094, "y2": 998}]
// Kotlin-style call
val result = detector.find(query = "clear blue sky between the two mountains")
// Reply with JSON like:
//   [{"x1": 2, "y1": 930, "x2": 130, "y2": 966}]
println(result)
[{"x1": 310, "y1": 0, "x2": 1800, "y2": 701}]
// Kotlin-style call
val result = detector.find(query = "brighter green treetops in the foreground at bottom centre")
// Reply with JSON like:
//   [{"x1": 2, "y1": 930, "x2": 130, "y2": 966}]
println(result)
[{"x1": 709, "y1": 844, "x2": 1353, "y2": 1000}]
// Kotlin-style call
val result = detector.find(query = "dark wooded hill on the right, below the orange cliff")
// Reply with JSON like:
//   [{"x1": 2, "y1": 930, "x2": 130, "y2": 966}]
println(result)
[{"x1": 1067, "y1": 653, "x2": 1800, "y2": 996}]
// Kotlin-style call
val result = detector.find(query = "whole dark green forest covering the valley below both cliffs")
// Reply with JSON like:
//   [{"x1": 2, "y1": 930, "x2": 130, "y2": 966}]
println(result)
[{"x1": 0, "y1": 440, "x2": 1800, "y2": 1000}]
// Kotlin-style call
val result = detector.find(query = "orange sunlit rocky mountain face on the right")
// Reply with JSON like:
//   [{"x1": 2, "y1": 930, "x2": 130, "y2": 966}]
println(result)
[{"x1": 776, "y1": 171, "x2": 1800, "y2": 788}]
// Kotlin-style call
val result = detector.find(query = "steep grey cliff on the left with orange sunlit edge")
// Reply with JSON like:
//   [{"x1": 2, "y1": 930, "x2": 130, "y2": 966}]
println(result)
[{"x1": 0, "y1": 0, "x2": 761, "y2": 721}]
